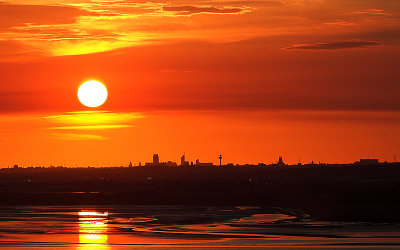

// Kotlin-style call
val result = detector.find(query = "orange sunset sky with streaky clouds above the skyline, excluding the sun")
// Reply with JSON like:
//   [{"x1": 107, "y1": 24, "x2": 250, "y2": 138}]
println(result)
[{"x1": 0, "y1": 0, "x2": 400, "y2": 167}]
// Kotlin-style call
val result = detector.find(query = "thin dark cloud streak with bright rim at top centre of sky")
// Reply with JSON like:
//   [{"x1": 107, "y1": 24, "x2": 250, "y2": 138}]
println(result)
[{"x1": 163, "y1": 5, "x2": 248, "y2": 15}]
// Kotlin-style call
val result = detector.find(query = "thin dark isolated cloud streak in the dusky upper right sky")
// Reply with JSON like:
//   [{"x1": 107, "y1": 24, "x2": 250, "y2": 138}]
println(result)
[{"x1": 284, "y1": 41, "x2": 382, "y2": 50}]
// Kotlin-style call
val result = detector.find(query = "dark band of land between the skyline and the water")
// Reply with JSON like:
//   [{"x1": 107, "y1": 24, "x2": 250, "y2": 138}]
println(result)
[{"x1": 0, "y1": 164, "x2": 400, "y2": 222}]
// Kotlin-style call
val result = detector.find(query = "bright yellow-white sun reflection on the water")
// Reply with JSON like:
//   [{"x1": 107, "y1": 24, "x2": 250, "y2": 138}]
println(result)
[{"x1": 77, "y1": 210, "x2": 110, "y2": 250}]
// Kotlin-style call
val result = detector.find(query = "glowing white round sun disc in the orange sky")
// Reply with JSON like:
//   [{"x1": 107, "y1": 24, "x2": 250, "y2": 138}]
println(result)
[{"x1": 78, "y1": 80, "x2": 108, "y2": 108}]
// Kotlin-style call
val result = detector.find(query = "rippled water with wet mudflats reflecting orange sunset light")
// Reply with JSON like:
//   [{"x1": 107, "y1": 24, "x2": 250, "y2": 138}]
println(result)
[{"x1": 0, "y1": 206, "x2": 400, "y2": 250}]
